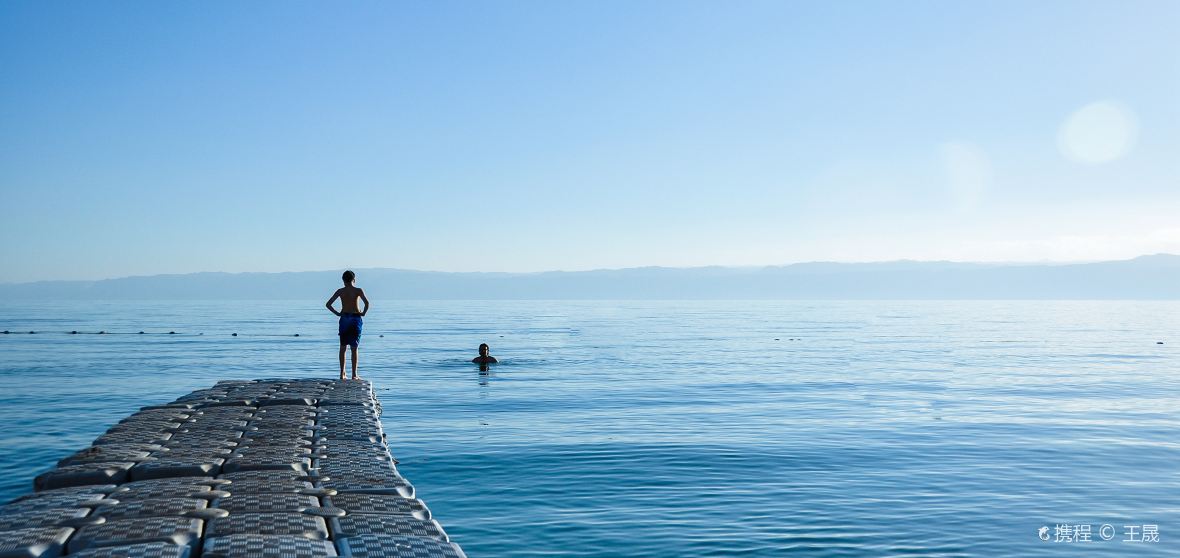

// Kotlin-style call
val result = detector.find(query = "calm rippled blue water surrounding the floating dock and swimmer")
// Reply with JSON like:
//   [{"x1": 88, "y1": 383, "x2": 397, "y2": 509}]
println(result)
[{"x1": 0, "y1": 301, "x2": 1180, "y2": 557}]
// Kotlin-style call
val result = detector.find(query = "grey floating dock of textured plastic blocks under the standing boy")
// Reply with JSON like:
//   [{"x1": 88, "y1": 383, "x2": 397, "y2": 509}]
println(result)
[{"x1": 0, "y1": 380, "x2": 464, "y2": 558}]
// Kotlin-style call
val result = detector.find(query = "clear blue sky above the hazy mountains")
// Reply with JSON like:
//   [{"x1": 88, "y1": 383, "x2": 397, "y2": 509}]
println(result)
[{"x1": 0, "y1": 0, "x2": 1180, "y2": 282}]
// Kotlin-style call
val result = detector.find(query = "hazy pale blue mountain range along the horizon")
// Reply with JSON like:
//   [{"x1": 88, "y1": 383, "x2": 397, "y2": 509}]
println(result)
[{"x1": 0, "y1": 254, "x2": 1180, "y2": 301}]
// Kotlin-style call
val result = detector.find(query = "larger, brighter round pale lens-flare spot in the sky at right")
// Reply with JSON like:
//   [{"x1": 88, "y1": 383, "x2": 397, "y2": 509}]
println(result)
[{"x1": 1057, "y1": 101, "x2": 1139, "y2": 163}]
